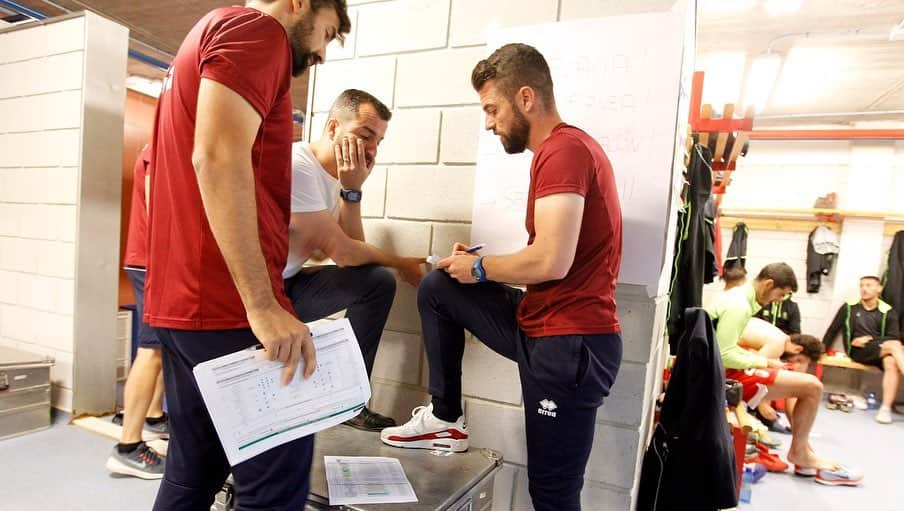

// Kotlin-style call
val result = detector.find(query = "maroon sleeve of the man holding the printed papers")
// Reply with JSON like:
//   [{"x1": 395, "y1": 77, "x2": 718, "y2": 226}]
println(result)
[{"x1": 200, "y1": 14, "x2": 292, "y2": 117}]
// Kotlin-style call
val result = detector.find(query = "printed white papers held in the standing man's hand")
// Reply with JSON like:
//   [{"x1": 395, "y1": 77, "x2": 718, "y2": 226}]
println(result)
[{"x1": 194, "y1": 319, "x2": 370, "y2": 465}]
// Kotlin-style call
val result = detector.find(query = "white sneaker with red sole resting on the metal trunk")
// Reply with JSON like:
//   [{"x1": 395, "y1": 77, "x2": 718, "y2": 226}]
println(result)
[{"x1": 380, "y1": 403, "x2": 468, "y2": 452}]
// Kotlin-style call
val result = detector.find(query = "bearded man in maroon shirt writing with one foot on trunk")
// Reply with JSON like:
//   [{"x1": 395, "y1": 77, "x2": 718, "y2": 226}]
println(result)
[{"x1": 381, "y1": 44, "x2": 622, "y2": 511}]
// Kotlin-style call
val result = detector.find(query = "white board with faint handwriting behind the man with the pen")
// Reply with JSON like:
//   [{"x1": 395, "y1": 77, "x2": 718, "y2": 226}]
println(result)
[{"x1": 471, "y1": 12, "x2": 686, "y2": 296}]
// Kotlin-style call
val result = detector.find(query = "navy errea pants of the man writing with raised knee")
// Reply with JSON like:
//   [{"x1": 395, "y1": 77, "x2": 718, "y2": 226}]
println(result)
[{"x1": 418, "y1": 271, "x2": 622, "y2": 511}]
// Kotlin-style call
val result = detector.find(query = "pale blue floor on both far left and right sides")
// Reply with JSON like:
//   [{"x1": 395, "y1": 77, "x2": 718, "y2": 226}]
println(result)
[{"x1": 0, "y1": 408, "x2": 904, "y2": 511}]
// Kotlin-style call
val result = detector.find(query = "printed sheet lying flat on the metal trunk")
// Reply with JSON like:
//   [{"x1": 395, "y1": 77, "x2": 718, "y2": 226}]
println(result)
[{"x1": 323, "y1": 456, "x2": 417, "y2": 506}]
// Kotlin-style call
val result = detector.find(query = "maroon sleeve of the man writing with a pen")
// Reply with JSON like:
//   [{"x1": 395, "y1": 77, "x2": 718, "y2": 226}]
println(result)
[{"x1": 534, "y1": 137, "x2": 593, "y2": 199}]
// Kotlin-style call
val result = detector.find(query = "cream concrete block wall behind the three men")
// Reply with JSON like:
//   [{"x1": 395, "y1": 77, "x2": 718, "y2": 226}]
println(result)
[{"x1": 308, "y1": 0, "x2": 674, "y2": 511}]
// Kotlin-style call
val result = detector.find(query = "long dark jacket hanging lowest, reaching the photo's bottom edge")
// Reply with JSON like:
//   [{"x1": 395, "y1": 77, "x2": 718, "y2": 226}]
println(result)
[{"x1": 637, "y1": 308, "x2": 738, "y2": 511}]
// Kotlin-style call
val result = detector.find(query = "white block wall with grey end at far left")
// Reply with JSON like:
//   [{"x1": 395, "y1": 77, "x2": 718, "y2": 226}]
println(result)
[{"x1": 0, "y1": 14, "x2": 128, "y2": 411}]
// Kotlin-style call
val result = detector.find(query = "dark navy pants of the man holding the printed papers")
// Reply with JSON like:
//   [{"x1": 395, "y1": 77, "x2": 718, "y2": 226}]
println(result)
[{"x1": 154, "y1": 328, "x2": 314, "y2": 511}]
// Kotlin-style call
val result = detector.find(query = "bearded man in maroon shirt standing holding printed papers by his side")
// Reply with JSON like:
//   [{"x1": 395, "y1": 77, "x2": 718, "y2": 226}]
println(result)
[{"x1": 145, "y1": 0, "x2": 351, "y2": 511}]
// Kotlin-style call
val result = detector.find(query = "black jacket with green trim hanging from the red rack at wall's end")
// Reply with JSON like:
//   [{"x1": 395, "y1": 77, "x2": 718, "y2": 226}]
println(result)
[{"x1": 668, "y1": 144, "x2": 713, "y2": 354}]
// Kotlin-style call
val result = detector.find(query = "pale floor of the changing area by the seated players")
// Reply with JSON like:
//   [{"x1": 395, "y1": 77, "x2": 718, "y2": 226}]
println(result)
[{"x1": 738, "y1": 405, "x2": 904, "y2": 511}]
